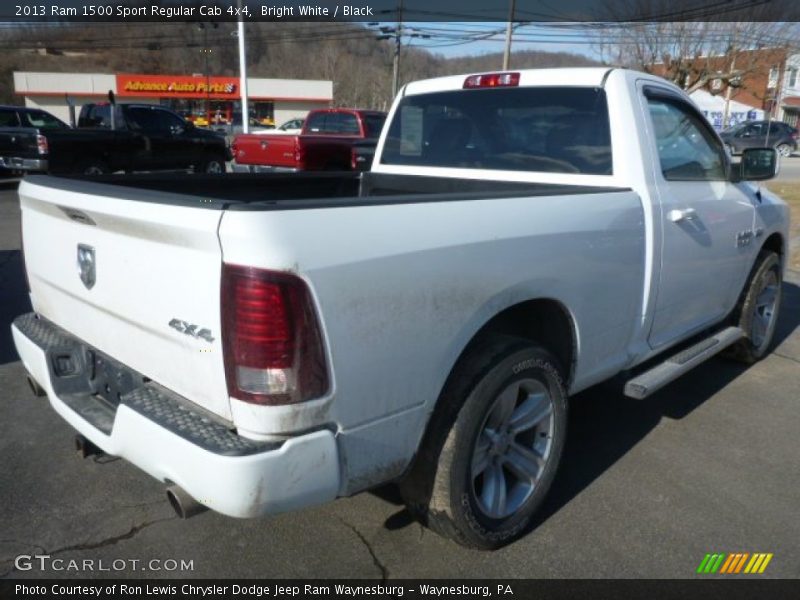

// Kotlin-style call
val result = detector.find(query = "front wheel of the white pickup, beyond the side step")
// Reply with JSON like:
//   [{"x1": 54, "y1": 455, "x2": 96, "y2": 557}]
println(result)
[{"x1": 727, "y1": 250, "x2": 783, "y2": 364}]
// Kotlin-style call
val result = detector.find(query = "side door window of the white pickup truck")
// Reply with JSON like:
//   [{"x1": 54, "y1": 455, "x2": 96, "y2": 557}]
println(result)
[{"x1": 647, "y1": 96, "x2": 726, "y2": 181}]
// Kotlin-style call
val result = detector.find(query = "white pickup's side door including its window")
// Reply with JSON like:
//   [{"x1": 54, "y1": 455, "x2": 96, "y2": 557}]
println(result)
[{"x1": 643, "y1": 85, "x2": 755, "y2": 348}]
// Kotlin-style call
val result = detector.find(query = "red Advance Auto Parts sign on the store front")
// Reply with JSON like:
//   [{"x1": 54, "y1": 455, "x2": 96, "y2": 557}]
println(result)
[{"x1": 117, "y1": 75, "x2": 239, "y2": 99}]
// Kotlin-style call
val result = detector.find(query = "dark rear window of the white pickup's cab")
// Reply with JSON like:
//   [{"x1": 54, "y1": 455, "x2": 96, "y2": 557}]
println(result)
[{"x1": 381, "y1": 87, "x2": 612, "y2": 175}]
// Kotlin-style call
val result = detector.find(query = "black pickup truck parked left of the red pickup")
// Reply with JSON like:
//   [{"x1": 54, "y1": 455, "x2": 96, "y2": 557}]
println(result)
[{"x1": 0, "y1": 103, "x2": 230, "y2": 175}]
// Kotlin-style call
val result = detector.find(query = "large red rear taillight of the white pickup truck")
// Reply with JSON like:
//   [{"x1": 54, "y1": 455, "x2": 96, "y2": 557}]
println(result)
[{"x1": 222, "y1": 264, "x2": 328, "y2": 404}]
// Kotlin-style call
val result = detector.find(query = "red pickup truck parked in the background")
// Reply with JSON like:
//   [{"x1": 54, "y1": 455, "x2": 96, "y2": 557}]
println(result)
[{"x1": 231, "y1": 108, "x2": 386, "y2": 172}]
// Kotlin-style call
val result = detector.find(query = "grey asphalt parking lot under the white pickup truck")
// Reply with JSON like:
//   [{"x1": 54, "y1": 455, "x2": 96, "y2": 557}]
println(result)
[{"x1": 0, "y1": 183, "x2": 800, "y2": 578}]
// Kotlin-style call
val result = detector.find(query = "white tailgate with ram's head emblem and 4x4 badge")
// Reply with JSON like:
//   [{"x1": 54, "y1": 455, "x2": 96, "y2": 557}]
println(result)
[{"x1": 19, "y1": 177, "x2": 231, "y2": 419}]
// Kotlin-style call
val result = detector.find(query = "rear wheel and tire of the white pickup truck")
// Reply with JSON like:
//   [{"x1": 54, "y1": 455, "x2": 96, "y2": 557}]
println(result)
[{"x1": 400, "y1": 336, "x2": 567, "y2": 550}]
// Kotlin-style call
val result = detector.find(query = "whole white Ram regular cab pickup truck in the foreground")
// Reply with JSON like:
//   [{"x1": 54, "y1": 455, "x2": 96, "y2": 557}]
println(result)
[{"x1": 12, "y1": 68, "x2": 788, "y2": 548}]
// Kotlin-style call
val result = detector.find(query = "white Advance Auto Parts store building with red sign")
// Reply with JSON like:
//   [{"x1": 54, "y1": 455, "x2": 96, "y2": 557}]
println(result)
[{"x1": 14, "y1": 72, "x2": 333, "y2": 127}]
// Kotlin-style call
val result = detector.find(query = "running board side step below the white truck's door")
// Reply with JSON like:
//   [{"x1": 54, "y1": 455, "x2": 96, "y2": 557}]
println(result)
[{"x1": 624, "y1": 327, "x2": 744, "y2": 400}]
